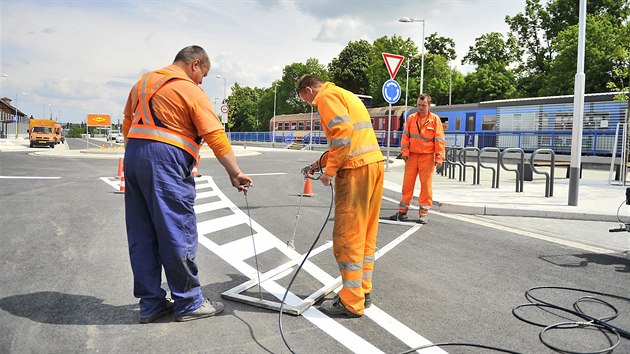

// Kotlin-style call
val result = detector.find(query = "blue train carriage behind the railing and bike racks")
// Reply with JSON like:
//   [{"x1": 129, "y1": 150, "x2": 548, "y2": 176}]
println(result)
[{"x1": 431, "y1": 93, "x2": 628, "y2": 155}]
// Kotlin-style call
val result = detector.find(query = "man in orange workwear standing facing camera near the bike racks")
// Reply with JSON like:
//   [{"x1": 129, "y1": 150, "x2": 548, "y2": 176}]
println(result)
[{"x1": 390, "y1": 93, "x2": 445, "y2": 224}]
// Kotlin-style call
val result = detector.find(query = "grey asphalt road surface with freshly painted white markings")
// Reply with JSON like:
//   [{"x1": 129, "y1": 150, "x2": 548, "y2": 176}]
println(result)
[{"x1": 0, "y1": 148, "x2": 630, "y2": 353}]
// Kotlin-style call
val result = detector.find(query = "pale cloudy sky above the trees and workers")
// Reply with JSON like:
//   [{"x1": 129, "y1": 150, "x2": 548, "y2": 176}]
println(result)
[{"x1": 0, "y1": 0, "x2": 525, "y2": 123}]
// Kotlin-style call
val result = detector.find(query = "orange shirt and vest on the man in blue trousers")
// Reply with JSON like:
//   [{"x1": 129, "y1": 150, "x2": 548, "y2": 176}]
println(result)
[{"x1": 123, "y1": 65, "x2": 229, "y2": 159}]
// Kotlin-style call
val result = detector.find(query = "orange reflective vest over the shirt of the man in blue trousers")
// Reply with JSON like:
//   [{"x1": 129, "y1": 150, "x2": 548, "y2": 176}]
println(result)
[{"x1": 127, "y1": 69, "x2": 201, "y2": 160}]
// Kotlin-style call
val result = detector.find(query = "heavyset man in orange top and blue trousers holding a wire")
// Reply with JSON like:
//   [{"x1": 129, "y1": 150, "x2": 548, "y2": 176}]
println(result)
[{"x1": 123, "y1": 46, "x2": 252, "y2": 323}]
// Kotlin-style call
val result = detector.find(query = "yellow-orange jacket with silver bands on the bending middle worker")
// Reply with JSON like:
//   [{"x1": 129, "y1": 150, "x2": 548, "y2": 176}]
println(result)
[{"x1": 313, "y1": 82, "x2": 385, "y2": 176}]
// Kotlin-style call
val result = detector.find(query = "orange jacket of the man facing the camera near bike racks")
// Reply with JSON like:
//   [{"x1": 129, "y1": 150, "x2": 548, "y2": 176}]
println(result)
[{"x1": 400, "y1": 112, "x2": 445, "y2": 163}]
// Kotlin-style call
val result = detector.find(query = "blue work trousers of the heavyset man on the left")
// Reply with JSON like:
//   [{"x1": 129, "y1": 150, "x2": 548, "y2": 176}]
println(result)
[{"x1": 124, "y1": 139, "x2": 204, "y2": 317}]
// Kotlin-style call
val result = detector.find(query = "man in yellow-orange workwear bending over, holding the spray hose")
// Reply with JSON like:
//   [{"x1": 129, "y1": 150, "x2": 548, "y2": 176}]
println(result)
[{"x1": 297, "y1": 75, "x2": 385, "y2": 318}]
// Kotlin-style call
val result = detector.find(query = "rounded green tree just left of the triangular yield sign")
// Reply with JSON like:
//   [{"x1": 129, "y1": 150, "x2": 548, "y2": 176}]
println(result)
[{"x1": 328, "y1": 39, "x2": 372, "y2": 94}]
